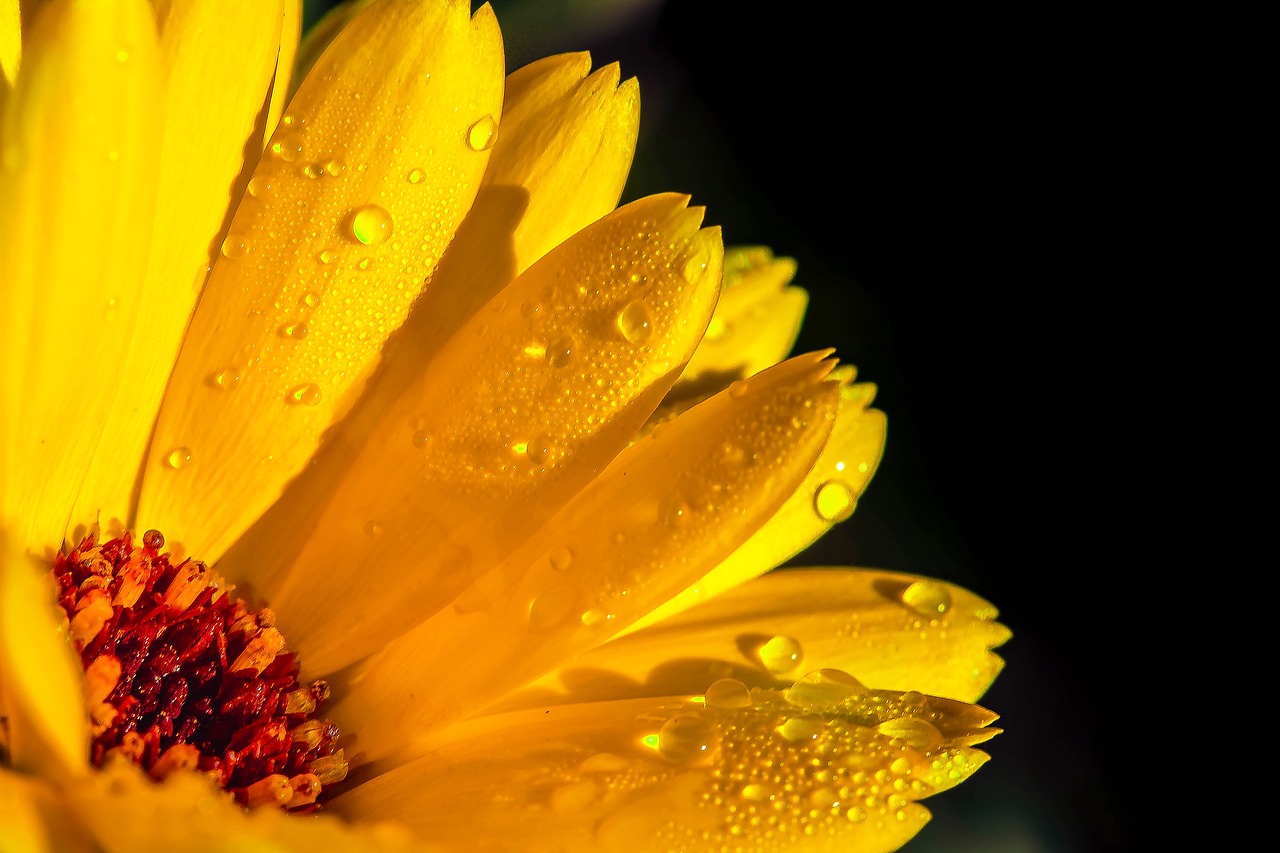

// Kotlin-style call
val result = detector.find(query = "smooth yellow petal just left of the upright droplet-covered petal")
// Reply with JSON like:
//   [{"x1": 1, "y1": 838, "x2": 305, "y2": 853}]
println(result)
[{"x1": 69, "y1": 0, "x2": 280, "y2": 532}]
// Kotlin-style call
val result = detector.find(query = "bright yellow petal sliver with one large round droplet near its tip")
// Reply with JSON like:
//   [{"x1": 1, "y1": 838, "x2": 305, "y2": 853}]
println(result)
[{"x1": 630, "y1": 366, "x2": 884, "y2": 630}]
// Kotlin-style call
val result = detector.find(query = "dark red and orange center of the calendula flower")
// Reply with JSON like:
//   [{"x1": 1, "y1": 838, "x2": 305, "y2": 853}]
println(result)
[{"x1": 52, "y1": 530, "x2": 347, "y2": 812}]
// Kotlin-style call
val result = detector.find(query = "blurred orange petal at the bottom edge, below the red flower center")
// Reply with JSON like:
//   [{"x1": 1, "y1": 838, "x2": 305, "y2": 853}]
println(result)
[{"x1": 67, "y1": 762, "x2": 430, "y2": 853}]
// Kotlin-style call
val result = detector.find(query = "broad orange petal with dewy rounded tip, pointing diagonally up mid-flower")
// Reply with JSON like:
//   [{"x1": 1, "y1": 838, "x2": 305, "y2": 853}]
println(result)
[{"x1": 262, "y1": 195, "x2": 721, "y2": 674}]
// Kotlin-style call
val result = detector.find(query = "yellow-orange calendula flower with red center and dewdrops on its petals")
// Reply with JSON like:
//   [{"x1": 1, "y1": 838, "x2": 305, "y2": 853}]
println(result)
[{"x1": 0, "y1": 0, "x2": 1007, "y2": 850}]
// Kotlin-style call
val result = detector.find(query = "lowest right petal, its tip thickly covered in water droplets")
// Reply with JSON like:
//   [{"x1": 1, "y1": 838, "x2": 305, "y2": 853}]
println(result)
[{"x1": 334, "y1": 686, "x2": 995, "y2": 852}]
